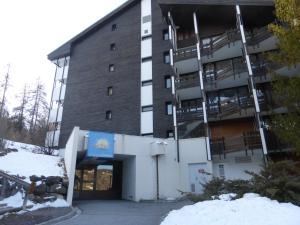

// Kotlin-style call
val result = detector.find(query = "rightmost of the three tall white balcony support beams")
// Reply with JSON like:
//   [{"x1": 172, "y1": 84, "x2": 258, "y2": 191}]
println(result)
[{"x1": 235, "y1": 5, "x2": 268, "y2": 163}]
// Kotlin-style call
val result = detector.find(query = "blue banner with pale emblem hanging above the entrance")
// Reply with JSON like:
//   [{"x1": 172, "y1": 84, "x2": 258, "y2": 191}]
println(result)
[{"x1": 87, "y1": 131, "x2": 115, "y2": 158}]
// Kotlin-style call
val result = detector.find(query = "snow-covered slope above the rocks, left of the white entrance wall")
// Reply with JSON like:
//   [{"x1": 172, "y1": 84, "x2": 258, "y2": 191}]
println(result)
[{"x1": 0, "y1": 141, "x2": 64, "y2": 182}]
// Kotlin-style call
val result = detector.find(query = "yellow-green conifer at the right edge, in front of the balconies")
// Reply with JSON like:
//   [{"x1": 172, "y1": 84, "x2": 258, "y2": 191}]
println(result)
[{"x1": 269, "y1": 0, "x2": 300, "y2": 154}]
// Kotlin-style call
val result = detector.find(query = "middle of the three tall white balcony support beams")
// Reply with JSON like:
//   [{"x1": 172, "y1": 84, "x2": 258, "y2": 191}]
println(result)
[{"x1": 193, "y1": 12, "x2": 211, "y2": 161}]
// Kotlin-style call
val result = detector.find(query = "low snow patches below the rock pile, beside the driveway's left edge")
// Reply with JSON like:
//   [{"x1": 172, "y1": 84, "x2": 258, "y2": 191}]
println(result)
[{"x1": 0, "y1": 192, "x2": 69, "y2": 211}]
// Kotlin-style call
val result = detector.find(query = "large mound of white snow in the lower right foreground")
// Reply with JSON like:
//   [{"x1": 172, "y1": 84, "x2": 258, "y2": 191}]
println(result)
[{"x1": 161, "y1": 193, "x2": 300, "y2": 225}]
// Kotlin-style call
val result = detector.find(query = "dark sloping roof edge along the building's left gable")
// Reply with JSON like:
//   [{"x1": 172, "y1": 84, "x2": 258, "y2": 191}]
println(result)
[{"x1": 48, "y1": 0, "x2": 140, "y2": 60}]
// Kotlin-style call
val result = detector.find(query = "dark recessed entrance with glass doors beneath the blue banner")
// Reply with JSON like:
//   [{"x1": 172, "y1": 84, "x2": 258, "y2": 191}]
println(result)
[{"x1": 74, "y1": 161, "x2": 123, "y2": 200}]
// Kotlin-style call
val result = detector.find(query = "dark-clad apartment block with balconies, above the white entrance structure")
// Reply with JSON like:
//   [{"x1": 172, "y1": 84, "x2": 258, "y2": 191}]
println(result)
[{"x1": 47, "y1": 0, "x2": 299, "y2": 200}]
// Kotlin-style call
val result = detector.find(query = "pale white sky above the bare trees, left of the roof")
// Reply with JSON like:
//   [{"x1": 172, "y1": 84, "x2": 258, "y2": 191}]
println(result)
[{"x1": 0, "y1": 0, "x2": 126, "y2": 110}]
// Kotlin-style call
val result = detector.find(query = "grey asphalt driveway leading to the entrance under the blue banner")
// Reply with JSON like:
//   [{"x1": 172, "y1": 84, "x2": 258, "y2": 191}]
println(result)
[{"x1": 56, "y1": 200, "x2": 192, "y2": 225}]
